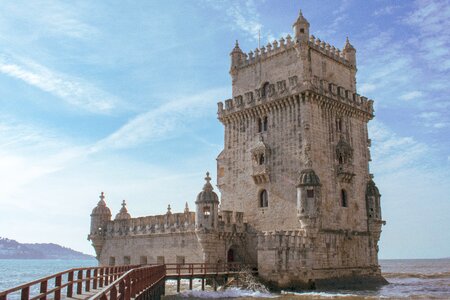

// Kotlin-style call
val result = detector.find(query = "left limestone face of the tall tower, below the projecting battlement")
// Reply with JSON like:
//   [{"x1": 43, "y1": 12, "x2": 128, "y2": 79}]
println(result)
[{"x1": 218, "y1": 98, "x2": 301, "y2": 230}]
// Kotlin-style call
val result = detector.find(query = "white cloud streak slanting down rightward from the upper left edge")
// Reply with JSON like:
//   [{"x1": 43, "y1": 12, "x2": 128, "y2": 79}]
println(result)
[{"x1": 0, "y1": 54, "x2": 119, "y2": 113}]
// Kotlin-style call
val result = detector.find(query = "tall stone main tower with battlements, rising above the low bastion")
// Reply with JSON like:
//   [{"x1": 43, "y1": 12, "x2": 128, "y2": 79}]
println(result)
[{"x1": 217, "y1": 12, "x2": 384, "y2": 287}]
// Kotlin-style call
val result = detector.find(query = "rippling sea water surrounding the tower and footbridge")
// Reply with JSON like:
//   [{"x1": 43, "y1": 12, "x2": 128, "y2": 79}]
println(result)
[{"x1": 0, "y1": 259, "x2": 450, "y2": 300}]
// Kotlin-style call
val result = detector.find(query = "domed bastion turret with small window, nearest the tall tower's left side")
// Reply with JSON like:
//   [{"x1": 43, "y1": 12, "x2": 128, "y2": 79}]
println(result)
[{"x1": 195, "y1": 172, "x2": 219, "y2": 229}]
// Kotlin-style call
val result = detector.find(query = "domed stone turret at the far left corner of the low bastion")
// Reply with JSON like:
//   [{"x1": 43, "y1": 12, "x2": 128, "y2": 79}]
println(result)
[{"x1": 88, "y1": 192, "x2": 111, "y2": 257}]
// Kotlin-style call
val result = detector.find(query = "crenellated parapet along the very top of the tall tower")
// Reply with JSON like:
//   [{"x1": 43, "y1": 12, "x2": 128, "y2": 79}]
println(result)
[{"x1": 235, "y1": 35, "x2": 354, "y2": 69}]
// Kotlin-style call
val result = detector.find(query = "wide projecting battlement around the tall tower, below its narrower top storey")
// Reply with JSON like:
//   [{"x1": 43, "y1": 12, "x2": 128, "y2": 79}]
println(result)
[{"x1": 217, "y1": 76, "x2": 373, "y2": 122}]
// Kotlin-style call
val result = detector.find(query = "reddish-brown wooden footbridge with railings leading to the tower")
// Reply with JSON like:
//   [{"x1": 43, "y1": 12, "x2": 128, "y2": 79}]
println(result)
[{"x1": 0, "y1": 263, "x2": 251, "y2": 300}]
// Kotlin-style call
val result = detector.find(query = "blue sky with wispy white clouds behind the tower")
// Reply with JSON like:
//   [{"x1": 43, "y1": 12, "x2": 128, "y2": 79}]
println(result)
[{"x1": 0, "y1": 0, "x2": 450, "y2": 258}]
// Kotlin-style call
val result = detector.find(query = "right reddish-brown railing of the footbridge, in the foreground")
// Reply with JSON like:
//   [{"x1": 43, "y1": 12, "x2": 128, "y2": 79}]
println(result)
[{"x1": 89, "y1": 265, "x2": 166, "y2": 300}]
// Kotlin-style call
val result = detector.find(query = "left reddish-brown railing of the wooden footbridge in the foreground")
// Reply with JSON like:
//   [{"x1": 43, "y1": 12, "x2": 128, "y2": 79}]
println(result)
[{"x1": 0, "y1": 266, "x2": 137, "y2": 300}]
